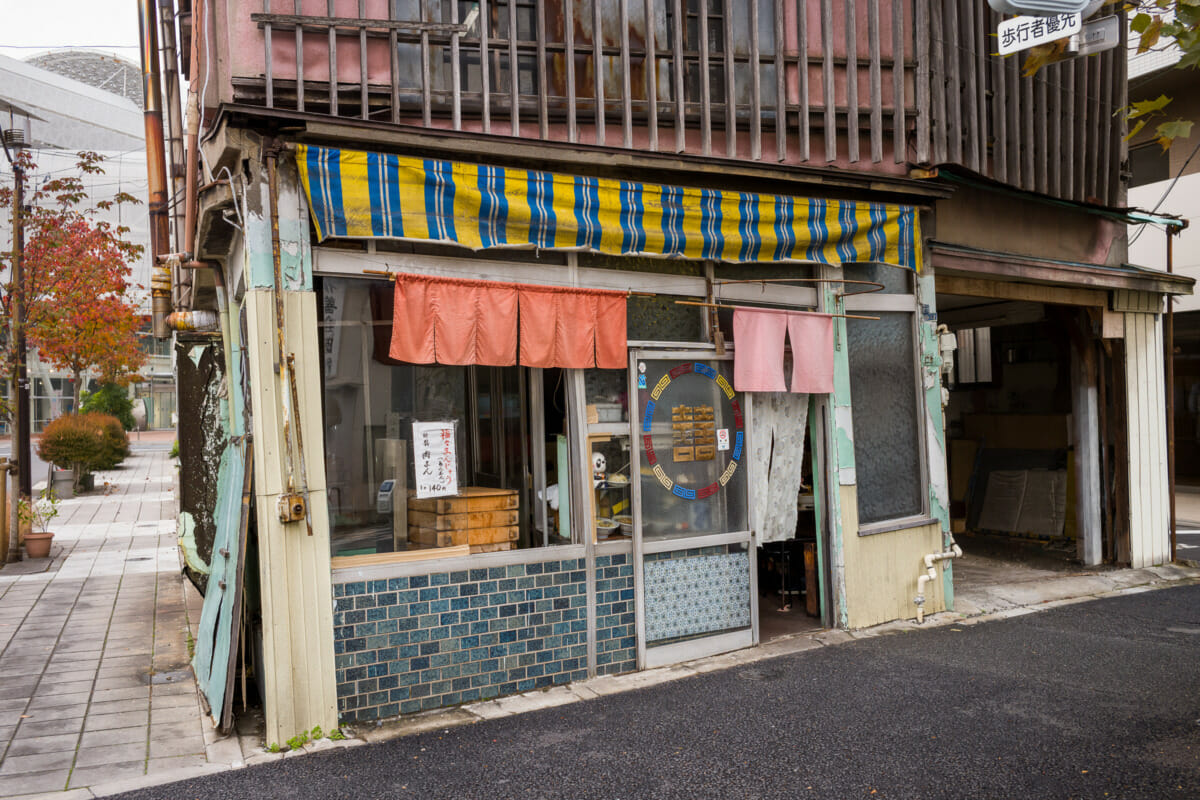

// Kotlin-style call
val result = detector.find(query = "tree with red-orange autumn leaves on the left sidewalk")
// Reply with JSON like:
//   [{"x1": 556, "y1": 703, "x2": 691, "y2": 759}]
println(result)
[{"x1": 0, "y1": 151, "x2": 145, "y2": 409}]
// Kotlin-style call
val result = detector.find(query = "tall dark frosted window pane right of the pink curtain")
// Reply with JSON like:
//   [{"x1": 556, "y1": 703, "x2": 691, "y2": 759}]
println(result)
[{"x1": 846, "y1": 312, "x2": 924, "y2": 525}]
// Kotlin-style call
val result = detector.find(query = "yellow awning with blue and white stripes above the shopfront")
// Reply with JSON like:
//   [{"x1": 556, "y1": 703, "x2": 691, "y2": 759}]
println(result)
[{"x1": 296, "y1": 145, "x2": 920, "y2": 272}]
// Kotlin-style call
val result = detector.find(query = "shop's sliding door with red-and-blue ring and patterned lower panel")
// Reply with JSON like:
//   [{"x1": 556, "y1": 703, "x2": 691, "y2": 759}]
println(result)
[{"x1": 630, "y1": 350, "x2": 757, "y2": 668}]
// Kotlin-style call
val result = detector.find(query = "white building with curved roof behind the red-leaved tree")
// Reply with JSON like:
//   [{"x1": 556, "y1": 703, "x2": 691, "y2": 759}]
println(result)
[{"x1": 0, "y1": 50, "x2": 175, "y2": 432}]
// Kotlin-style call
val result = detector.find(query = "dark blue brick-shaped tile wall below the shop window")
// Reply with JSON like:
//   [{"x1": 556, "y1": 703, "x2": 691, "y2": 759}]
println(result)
[{"x1": 334, "y1": 557, "x2": 588, "y2": 722}]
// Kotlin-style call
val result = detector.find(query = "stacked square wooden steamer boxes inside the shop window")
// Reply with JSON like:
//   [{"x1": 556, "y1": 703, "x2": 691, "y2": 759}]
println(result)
[{"x1": 408, "y1": 486, "x2": 521, "y2": 553}]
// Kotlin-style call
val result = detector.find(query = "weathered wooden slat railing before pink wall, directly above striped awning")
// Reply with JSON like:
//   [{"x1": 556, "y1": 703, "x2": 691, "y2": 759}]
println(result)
[{"x1": 234, "y1": 0, "x2": 925, "y2": 172}]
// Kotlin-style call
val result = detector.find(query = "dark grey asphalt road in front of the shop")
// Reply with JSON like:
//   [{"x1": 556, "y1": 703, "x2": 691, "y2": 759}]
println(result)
[{"x1": 105, "y1": 585, "x2": 1200, "y2": 800}]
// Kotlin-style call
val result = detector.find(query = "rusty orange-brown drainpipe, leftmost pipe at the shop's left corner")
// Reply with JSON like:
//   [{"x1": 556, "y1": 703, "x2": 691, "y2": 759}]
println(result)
[{"x1": 138, "y1": 0, "x2": 173, "y2": 339}]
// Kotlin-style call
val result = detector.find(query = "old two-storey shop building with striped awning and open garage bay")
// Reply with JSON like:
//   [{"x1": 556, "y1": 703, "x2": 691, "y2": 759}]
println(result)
[{"x1": 166, "y1": 0, "x2": 1192, "y2": 741}]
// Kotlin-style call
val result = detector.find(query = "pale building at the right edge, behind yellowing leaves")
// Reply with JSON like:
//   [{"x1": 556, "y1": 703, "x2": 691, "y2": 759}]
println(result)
[{"x1": 1129, "y1": 50, "x2": 1200, "y2": 487}]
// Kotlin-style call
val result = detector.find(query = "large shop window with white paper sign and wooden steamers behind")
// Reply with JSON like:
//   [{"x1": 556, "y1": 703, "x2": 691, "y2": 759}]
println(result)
[{"x1": 320, "y1": 278, "x2": 571, "y2": 557}]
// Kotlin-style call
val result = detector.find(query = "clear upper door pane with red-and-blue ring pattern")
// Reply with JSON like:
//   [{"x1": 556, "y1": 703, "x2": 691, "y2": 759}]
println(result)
[{"x1": 637, "y1": 359, "x2": 748, "y2": 539}]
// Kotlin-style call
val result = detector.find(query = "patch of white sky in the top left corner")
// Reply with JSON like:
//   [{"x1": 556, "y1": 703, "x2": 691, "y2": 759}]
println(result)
[{"x1": 0, "y1": 0, "x2": 140, "y2": 64}]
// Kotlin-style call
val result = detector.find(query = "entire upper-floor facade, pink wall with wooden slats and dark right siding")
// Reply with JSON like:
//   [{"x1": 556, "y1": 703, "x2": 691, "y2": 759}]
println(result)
[{"x1": 206, "y1": 0, "x2": 1124, "y2": 201}]
